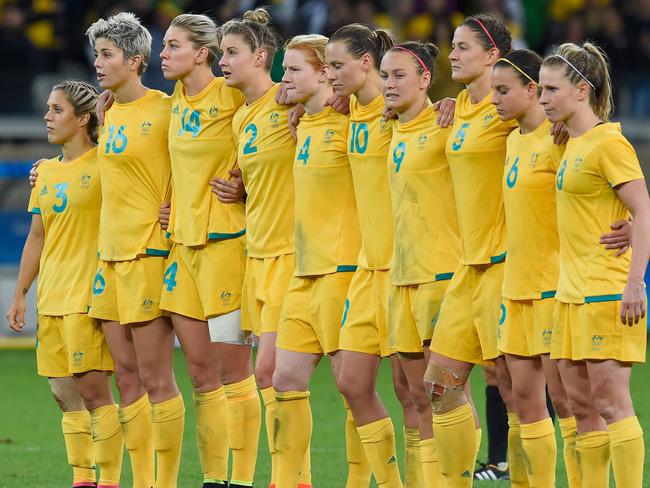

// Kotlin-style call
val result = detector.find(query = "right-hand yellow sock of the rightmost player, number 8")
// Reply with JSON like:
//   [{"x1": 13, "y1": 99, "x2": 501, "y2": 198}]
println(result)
[{"x1": 607, "y1": 417, "x2": 645, "y2": 488}]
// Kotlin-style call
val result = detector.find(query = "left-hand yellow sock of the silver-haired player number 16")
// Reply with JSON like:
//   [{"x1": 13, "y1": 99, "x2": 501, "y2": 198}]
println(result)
[{"x1": 118, "y1": 394, "x2": 155, "y2": 488}]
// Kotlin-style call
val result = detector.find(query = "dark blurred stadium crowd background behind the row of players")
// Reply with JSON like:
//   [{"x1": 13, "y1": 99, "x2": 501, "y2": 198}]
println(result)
[{"x1": 0, "y1": 0, "x2": 650, "y2": 336}]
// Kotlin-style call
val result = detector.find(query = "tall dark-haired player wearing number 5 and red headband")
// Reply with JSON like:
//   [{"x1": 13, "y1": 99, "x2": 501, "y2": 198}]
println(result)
[{"x1": 425, "y1": 15, "x2": 515, "y2": 487}]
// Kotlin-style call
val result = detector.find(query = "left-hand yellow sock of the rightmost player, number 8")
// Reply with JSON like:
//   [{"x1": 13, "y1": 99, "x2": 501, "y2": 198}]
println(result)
[{"x1": 576, "y1": 431, "x2": 610, "y2": 488}]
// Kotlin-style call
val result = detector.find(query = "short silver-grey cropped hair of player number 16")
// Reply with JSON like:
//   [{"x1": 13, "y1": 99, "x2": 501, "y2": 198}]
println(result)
[{"x1": 86, "y1": 12, "x2": 151, "y2": 75}]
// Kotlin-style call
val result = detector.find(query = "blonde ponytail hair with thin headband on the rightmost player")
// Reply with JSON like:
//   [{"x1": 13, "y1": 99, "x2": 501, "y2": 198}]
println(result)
[{"x1": 543, "y1": 42, "x2": 614, "y2": 122}]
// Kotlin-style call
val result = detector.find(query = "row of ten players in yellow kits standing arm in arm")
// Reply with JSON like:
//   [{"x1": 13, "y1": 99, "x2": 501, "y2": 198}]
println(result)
[{"x1": 7, "y1": 9, "x2": 650, "y2": 488}]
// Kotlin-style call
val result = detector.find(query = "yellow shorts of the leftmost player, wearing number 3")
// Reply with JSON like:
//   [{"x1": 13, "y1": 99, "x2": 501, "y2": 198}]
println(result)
[{"x1": 36, "y1": 313, "x2": 113, "y2": 378}]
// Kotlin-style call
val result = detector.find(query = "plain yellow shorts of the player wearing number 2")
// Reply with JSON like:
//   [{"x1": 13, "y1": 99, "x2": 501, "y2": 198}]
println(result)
[{"x1": 241, "y1": 254, "x2": 295, "y2": 336}]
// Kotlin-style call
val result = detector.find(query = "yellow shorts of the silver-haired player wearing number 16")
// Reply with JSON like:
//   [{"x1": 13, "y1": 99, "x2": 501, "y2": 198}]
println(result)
[{"x1": 89, "y1": 256, "x2": 165, "y2": 325}]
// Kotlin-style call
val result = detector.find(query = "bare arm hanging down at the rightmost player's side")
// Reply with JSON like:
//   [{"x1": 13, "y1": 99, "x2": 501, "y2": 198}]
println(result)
[{"x1": 616, "y1": 180, "x2": 650, "y2": 325}]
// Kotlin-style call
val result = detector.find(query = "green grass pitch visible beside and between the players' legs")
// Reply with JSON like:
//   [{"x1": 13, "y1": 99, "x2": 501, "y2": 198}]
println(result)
[{"x1": 0, "y1": 350, "x2": 650, "y2": 488}]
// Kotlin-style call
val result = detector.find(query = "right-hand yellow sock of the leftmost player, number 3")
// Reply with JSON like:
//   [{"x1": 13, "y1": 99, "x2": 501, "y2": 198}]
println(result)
[{"x1": 90, "y1": 405, "x2": 124, "y2": 487}]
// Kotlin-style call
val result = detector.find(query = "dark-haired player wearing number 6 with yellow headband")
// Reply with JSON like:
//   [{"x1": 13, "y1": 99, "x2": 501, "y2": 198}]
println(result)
[{"x1": 492, "y1": 50, "x2": 580, "y2": 488}]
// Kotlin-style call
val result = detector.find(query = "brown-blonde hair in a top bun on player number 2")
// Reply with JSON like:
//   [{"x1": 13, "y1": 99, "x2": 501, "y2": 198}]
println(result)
[{"x1": 221, "y1": 8, "x2": 278, "y2": 71}]
